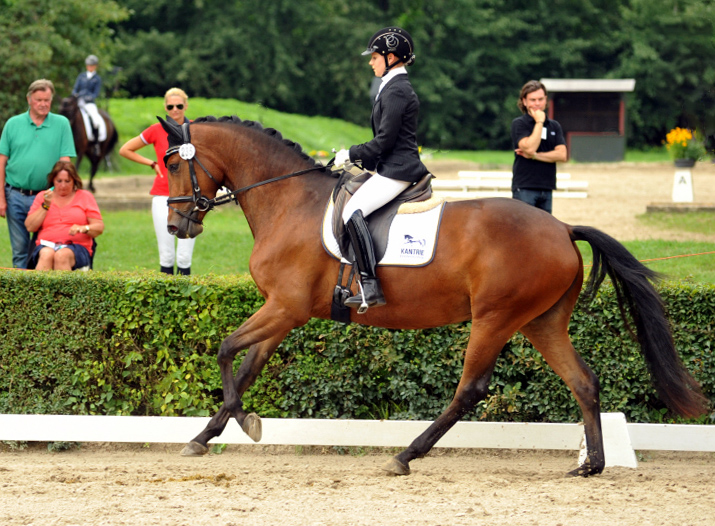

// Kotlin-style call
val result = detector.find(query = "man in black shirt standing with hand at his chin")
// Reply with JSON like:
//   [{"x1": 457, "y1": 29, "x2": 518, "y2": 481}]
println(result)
[{"x1": 511, "y1": 80, "x2": 568, "y2": 213}]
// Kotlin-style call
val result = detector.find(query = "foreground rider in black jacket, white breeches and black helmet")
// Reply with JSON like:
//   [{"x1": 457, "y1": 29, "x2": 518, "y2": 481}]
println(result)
[{"x1": 335, "y1": 27, "x2": 429, "y2": 308}]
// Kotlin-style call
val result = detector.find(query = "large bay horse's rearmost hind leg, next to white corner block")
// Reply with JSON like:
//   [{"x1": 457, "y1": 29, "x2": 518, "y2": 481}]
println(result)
[{"x1": 520, "y1": 306, "x2": 606, "y2": 477}]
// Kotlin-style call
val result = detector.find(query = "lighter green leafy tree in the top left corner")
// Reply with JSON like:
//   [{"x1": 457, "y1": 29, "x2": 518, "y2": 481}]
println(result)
[{"x1": 0, "y1": 0, "x2": 129, "y2": 127}]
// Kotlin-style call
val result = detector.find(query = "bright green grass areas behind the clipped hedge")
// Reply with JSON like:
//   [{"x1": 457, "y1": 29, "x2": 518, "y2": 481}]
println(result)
[{"x1": 0, "y1": 97, "x2": 715, "y2": 283}]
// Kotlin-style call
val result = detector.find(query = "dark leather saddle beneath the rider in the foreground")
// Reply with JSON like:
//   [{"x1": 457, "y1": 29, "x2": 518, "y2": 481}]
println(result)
[{"x1": 332, "y1": 171, "x2": 434, "y2": 261}]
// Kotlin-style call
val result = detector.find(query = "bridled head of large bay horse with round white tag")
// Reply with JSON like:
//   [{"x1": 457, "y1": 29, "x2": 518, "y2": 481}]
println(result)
[{"x1": 157, "y1": 117, "x2": 223, "y2": 238}]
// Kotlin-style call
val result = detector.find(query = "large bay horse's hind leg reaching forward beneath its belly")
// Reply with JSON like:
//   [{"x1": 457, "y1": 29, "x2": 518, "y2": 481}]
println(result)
[{"x1": 382, "y1": 328, "x2": 512, "y2": 475}]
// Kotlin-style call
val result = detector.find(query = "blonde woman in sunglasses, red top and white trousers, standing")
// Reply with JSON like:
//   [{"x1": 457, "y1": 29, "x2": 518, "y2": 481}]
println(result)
[{"x1": 119, "y1": 88, "x2": 195, "y2": 276}]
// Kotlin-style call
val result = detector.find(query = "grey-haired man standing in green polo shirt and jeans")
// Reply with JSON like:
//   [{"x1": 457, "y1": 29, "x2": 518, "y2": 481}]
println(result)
[{"x1": 0, "y1": 79, "x2": 76, "y2": 268}]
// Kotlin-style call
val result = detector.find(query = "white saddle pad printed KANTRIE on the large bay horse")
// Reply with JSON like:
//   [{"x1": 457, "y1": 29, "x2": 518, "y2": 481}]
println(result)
[{"x1": 321, "y1": 197, "x2": 445, "y2": 267}]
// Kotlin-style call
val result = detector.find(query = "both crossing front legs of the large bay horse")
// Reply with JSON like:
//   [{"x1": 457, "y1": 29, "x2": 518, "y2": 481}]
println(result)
[{"x1": 182, "y1": 304, "x2": 297, "y2": 456}]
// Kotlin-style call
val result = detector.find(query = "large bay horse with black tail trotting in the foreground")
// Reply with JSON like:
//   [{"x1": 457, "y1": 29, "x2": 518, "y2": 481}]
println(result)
[{"x1": 159, "y1": 117, "x2": 708, "y2": 476}]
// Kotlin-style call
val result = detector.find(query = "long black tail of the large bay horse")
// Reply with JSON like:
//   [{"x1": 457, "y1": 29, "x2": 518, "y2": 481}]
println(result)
[{"x1": 571, "y1": 226, "x2": 709, "y2": 417}]
